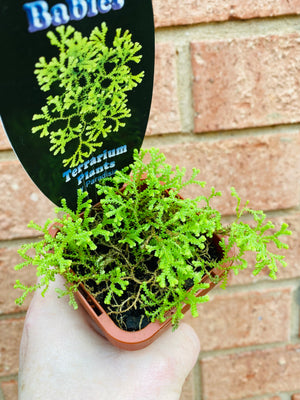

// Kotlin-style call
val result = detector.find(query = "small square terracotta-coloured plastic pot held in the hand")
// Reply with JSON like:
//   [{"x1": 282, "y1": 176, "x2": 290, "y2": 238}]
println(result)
[{"x1": 49, "y1": 225, "x2": 230, "y2": 350}]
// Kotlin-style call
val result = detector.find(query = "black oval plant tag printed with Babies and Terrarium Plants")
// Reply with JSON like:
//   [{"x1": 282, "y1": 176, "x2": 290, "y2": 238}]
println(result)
[{"x1": 0, "y1": 0, "x2": 154, "y2": 208}]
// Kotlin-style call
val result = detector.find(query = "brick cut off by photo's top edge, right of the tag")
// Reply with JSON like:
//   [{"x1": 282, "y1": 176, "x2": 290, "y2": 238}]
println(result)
[{"x1": 153, "y1": 0, "x2": 300, "y2": 27}]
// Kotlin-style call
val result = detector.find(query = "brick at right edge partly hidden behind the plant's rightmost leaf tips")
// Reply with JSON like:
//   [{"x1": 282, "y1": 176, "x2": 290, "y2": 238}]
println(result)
[{"x1": 229, "y1": 213, "x2": 300, "y2": 285}]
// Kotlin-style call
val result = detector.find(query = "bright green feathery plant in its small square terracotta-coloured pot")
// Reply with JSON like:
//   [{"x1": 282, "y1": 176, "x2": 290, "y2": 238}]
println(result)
[{"x1": 15, "y1": 149, "x2": 291, "y2": 350}]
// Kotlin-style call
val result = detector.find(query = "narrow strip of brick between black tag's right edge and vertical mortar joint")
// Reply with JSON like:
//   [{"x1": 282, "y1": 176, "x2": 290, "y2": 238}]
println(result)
[{"x1": 147, "y1": 43, "x2": 181, "y2": 135}]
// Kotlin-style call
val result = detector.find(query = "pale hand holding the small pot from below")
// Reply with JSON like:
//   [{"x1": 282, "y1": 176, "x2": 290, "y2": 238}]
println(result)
[{"x1": 19, "y1": 278, "x2": 200, "y2": 400}]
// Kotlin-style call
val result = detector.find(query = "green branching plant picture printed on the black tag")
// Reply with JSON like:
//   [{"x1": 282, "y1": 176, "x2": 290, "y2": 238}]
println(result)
[{"x1": 32, "y1": 22, "x2": 144, "y2": 168}]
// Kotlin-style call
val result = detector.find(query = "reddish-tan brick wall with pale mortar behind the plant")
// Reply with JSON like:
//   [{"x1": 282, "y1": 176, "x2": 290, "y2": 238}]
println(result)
[{"x1": 0, "y1": 0, "x2": 300, "y2": 400}]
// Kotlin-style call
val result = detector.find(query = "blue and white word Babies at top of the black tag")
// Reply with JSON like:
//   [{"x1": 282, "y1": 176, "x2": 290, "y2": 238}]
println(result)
[{"x1": 23, "y1": 0, "x2": 125, "y2": 33}]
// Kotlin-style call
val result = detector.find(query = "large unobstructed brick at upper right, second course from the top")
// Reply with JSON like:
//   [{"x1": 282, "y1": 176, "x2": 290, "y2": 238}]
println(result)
[{"x1": 191, "y1": 34, "x2": 300, "y2": 132}]
